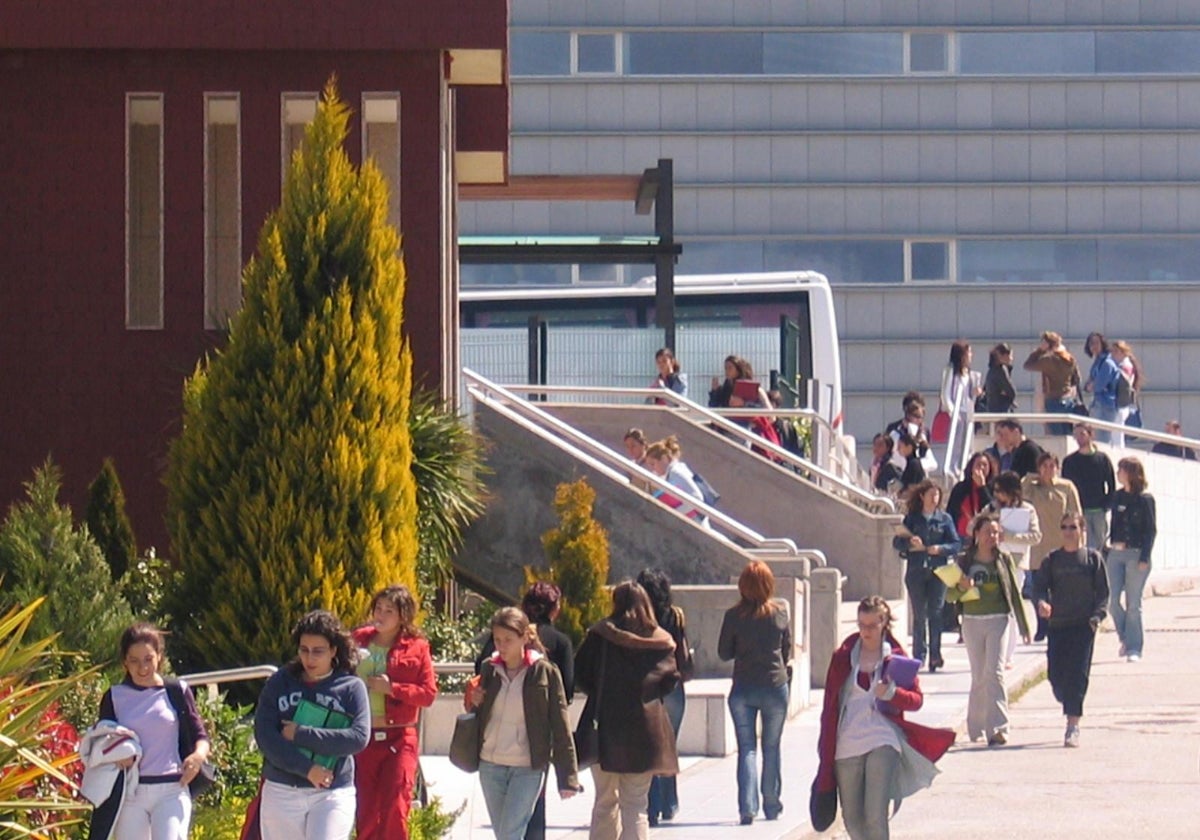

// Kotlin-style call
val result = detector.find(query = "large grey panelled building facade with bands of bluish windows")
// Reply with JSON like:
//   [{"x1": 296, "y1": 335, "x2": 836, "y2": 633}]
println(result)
[{"x1": 461, "y1": 0, "x2": 1200, "y2": 439}]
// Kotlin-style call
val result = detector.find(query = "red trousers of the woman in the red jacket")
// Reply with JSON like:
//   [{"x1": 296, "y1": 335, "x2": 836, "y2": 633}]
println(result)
[{"x1": 354, "y1": 727, "x2": 418, "y2": 840}]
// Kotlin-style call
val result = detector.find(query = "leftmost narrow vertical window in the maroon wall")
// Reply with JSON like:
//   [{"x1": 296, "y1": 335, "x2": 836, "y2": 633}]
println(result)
[{"x1": 125, "y1": 94, "x2": 162, "y2": 330}]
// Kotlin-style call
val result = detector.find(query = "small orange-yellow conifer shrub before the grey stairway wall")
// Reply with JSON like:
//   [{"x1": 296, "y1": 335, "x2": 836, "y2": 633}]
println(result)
[{"x1": 526, "y1": 479, "x2": 611, "y2": 647}]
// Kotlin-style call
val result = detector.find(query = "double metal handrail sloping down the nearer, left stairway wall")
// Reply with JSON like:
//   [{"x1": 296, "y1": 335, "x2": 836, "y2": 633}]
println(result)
[{"x1": 463, "y1": 368, "x2": 799, "y2": 557}]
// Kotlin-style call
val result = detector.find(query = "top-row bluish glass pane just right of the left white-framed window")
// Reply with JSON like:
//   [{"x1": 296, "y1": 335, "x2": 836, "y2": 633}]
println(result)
[{"x1": 625, "y1": 32, "x2": 763, "y2": 76}]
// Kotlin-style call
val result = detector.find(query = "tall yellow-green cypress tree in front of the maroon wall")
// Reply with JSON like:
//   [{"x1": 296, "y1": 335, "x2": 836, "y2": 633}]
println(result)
[{"x1": 164, "y1": 83, "x2": 416, "y2": 668}]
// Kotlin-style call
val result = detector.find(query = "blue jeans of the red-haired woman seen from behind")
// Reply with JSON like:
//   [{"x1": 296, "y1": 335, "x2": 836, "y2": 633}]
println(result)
[{"x1": 730, "y1": 683, "x2": 787, "y2": 820}]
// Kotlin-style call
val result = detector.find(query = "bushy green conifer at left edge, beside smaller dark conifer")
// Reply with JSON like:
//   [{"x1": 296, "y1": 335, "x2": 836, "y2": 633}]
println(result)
[{"x1": 0, "y1": 458, "x2": 133, "y2": 664}]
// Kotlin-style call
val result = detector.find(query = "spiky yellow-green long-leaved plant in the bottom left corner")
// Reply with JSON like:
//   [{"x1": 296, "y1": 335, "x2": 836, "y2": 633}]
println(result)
[{"x1": 0, "y1": 598, "x2": 95, "y2": 838}]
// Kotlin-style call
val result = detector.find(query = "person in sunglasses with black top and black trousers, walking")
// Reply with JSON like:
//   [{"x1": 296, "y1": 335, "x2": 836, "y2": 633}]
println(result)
[{"x1": 1033, "y1": 514, "x2": 1109, "y2": 746}]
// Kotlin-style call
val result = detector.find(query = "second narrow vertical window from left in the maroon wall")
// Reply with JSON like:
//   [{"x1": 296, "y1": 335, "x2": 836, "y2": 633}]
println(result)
[{"x1": 204, "y1": 94, "x2": 241, "y2": 330}]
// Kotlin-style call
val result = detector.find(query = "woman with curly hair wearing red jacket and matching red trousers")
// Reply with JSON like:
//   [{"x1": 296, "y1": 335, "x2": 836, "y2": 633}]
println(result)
[{"x1": 354, "y1": 586, "x2": 438, "y2": 840}]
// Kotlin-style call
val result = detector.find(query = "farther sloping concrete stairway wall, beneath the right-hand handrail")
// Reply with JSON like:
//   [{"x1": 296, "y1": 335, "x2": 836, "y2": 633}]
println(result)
[{"x1": 541, "y1": 403, "x2": 905, "y2": 600}]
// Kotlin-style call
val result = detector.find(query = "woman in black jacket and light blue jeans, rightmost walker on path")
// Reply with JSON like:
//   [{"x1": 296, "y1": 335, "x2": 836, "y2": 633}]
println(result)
[{"x1": 1108, "y1": 458, "x2": 1158, "y2": 662}]
